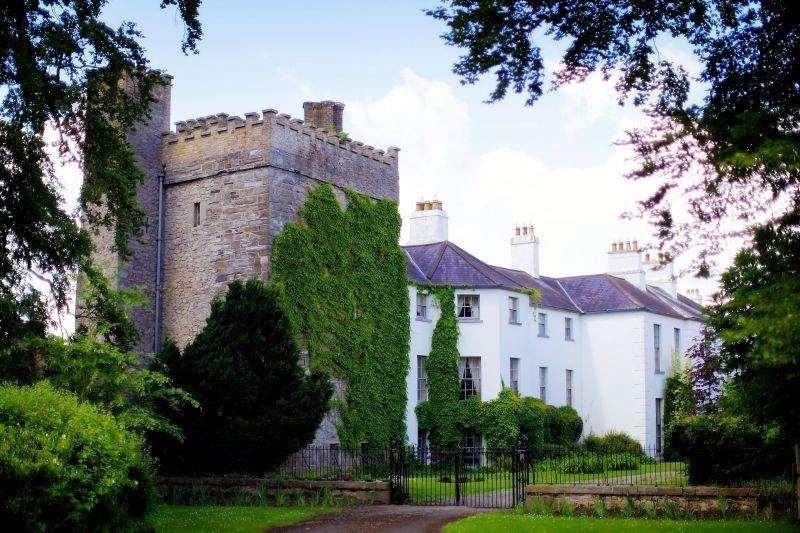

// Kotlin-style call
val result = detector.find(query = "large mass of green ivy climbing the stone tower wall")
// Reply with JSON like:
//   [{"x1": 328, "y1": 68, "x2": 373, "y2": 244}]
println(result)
[{"x1": 271, "y1": 185, "x2": 410, "y2": 449}]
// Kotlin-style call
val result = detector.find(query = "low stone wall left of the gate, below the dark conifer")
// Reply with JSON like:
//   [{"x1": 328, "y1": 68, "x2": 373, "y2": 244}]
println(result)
[{"x1": 157, "y1": 477, "x2": 389, "y2": 505}]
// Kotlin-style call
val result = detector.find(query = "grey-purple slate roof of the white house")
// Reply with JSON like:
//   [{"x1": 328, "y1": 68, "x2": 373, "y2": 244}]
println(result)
[{"x1": 403, "y1": 241, "x2": 702, "y2": 320}]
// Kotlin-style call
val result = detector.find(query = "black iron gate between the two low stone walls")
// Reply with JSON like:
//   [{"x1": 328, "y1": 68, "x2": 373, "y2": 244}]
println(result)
[{"x1": 389, "y1": 447, "x2": 532, "y2": 508}]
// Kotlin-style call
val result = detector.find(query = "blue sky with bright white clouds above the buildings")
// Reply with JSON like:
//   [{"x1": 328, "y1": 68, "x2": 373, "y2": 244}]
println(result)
[{"x1": 56, "y1": 0, "x2": 715, "y2": 318}]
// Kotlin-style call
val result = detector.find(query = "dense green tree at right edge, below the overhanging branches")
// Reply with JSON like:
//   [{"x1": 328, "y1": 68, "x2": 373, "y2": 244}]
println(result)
[{"x1": 708, "y1": 215, "x2": 800, "y2": 443}]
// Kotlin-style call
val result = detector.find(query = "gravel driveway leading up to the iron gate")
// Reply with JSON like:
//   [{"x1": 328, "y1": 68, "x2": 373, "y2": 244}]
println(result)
[{"x1": 268, "y1": 505, "x2": 482, "y2": 533}]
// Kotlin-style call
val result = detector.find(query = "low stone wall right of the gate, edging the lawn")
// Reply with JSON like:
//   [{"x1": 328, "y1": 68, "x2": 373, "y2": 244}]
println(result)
[{"x1": 525, "y1": 484, "x2": 788, "y2": 519}]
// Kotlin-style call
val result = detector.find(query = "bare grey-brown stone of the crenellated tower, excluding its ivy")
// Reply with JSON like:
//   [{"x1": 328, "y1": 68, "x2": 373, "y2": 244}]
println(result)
[{"x1": 83, "y1": 80, "x2": 399, "y2": 352}]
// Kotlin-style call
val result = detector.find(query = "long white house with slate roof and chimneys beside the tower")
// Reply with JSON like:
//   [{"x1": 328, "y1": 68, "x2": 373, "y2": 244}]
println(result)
[{"x1": 404, "y1": 201, "x2": 701, "y2": 453}]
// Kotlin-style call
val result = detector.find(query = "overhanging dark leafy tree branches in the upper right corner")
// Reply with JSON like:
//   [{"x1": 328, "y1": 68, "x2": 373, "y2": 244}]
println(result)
[{"x1": 428, "y1": 0, "x2": 800, "y2": 274}]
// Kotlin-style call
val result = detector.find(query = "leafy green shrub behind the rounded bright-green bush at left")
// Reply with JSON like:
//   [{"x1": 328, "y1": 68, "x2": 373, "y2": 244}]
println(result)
[{"x1": 0, "y1": 336, "x2": 196, "y2": 439}]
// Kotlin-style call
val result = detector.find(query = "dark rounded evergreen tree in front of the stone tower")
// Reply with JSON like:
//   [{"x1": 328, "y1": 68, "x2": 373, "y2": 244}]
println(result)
[{"x1": 153, "y1": 278, "x2": 333, "y2": 474}]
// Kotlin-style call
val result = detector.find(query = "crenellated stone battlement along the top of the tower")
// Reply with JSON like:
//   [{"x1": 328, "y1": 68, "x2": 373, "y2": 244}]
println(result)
[{"x1": 163, "y1": 109, "x2": 400, "y2": 166}]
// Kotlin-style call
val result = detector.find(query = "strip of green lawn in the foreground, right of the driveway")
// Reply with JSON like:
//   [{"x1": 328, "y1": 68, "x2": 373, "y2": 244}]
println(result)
[{"x1": 444, "y1": 512, "x2": 800, "y2": 533}]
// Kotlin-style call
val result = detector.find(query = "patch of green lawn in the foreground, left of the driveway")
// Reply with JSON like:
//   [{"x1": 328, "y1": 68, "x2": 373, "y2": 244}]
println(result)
[{"x1": 153, "y1": 505, "x2": 333, "y2": 533}]
